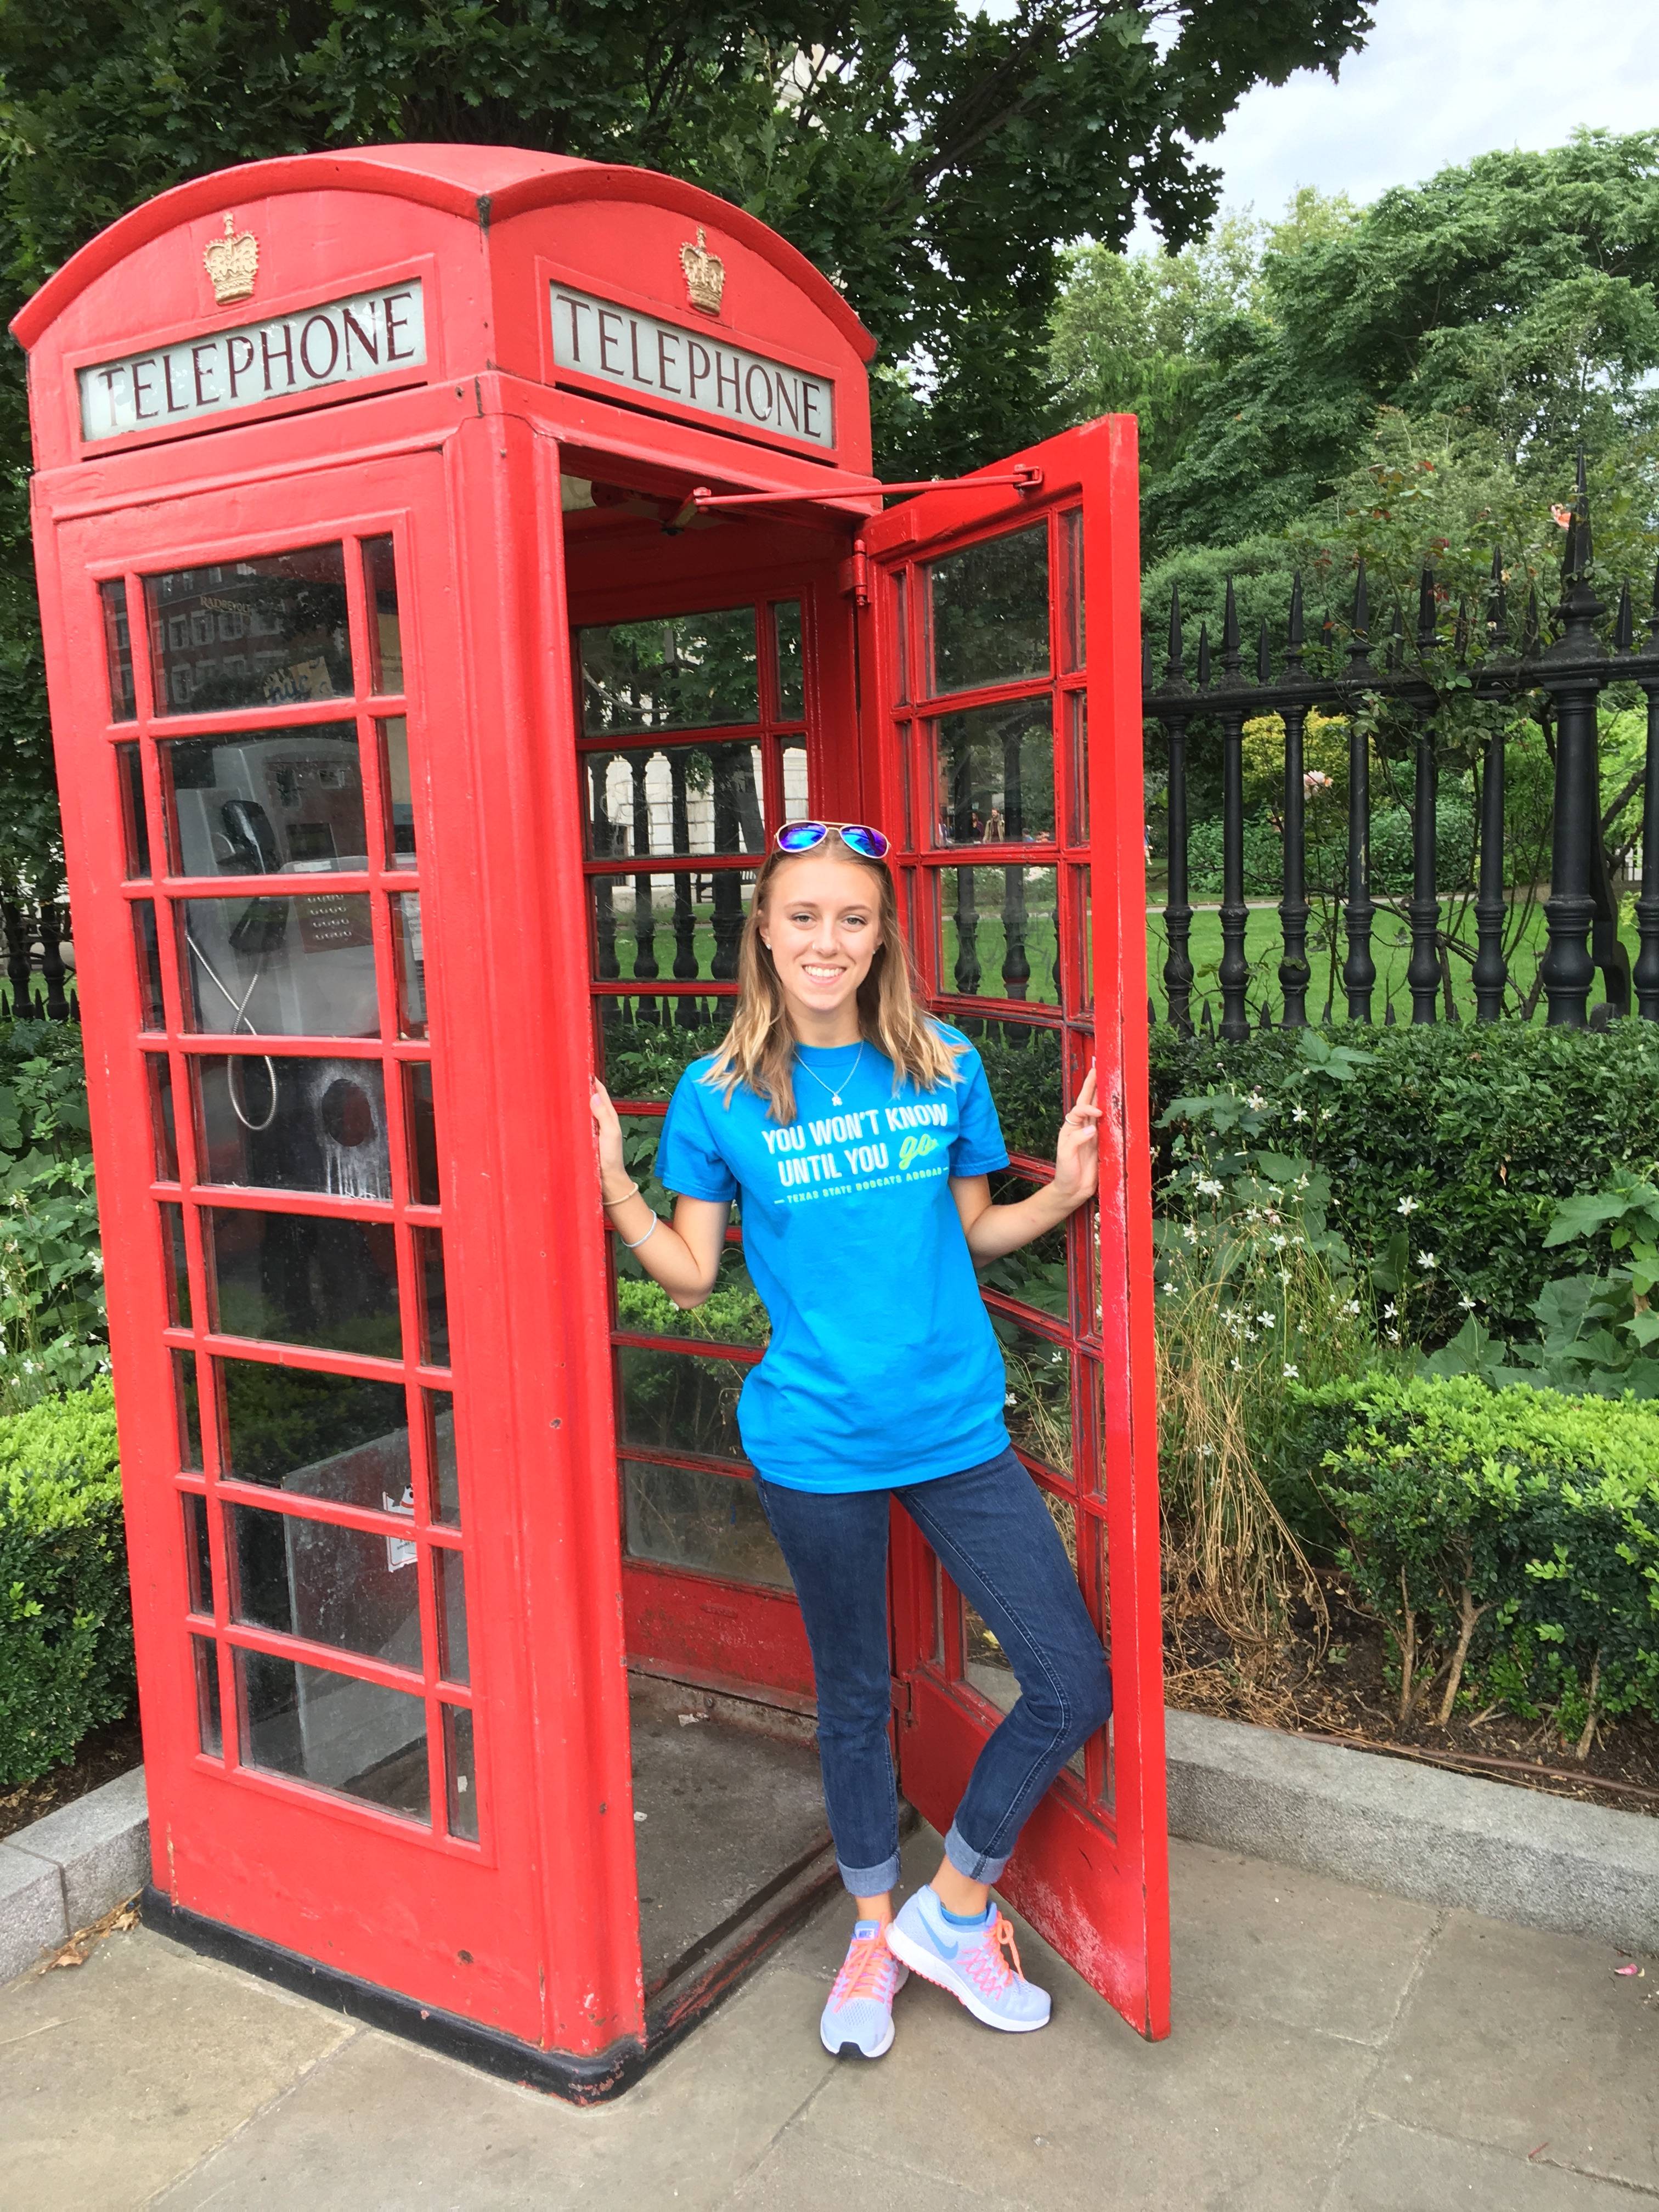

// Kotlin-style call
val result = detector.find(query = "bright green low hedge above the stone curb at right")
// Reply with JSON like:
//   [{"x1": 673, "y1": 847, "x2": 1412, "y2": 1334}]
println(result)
[{"x1": 1299, "y1": 1374, "x2": 1659, "y2": 1736}]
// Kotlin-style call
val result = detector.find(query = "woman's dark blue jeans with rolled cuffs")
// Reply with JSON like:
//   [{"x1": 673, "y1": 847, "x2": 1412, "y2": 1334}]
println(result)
[{"x1": 754, "y1": 1451, "x2": 1113, "y2": 1898}]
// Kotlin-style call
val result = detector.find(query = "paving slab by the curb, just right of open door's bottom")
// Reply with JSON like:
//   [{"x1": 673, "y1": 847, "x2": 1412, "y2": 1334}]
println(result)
[{"x1": 1170, "y1": 1843, "x2": 1442, "y2": 2046}]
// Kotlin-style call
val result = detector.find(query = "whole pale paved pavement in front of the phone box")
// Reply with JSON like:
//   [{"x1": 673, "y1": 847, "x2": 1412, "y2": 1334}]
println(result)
[{"x1": 0, "y1": 1834, "x2": 1659, "y2": 2212}]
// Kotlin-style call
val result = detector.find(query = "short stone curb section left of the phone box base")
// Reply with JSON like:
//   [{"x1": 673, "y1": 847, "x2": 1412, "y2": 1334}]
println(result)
[{"x1": 0, "y1": 1768, "x2": 150, "y2": 1982}]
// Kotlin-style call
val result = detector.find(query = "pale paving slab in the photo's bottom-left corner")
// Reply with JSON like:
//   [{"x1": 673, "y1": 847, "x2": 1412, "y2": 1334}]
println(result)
[{"x1": 0, "y1": 1929, "x2": 352, "y2": 2212}]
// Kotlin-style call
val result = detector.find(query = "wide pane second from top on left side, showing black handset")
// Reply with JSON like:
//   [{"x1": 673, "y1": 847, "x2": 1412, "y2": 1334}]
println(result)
[{"x1": 161, "y1": 721, "x2": 369, "y2": 876}]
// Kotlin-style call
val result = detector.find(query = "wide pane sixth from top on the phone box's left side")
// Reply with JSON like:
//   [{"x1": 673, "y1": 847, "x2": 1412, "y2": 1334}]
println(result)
[{"x1": 215, "y1": 1361, "x2": 409, "y2": 1513}]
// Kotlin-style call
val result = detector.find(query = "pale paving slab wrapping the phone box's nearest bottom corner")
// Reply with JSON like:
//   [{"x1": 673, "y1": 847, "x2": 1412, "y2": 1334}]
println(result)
[{"x1": 155, "y1": 1973, "x2": 834, "y2": 2212}]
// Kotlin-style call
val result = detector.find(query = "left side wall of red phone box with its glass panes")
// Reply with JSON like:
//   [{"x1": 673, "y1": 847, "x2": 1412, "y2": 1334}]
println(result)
[{"x1": 47, "y1": 454, "x2": 566, "y2": 2044}]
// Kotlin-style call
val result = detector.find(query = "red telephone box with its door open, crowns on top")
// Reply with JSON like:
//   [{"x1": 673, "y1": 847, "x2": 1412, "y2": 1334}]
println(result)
[{"x1": 13, "y1": 146, "x2": 1168, "y2": 2097}]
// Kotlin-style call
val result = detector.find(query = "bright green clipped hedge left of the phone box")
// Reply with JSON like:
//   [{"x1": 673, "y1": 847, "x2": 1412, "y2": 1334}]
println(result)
[{"x1": 0, "y1": 1383, "x2": 133, "y2": 1787}]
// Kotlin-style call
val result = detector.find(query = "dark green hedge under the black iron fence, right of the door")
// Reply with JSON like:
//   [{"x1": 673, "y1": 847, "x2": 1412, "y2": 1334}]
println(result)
[{"x1": 1153, "y1": 1022, "x2": 1659, "y2": 1342}]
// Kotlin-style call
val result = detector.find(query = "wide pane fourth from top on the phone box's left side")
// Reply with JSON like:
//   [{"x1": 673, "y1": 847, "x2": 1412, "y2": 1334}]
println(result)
[{"x1": 190, "y1": 1053, "x2": 392, "y2": 1199}]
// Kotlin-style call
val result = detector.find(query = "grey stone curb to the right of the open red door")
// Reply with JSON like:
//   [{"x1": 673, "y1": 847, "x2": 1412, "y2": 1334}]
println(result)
[{"x1": 1168, "y1": 1712, "x2": 1659, "y2": 1953}]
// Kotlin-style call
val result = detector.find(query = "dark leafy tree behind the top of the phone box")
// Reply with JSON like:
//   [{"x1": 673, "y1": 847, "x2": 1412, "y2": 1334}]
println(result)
[{"x1": 0, "y1": 0, "x2": 1372, "y2": 878}]
